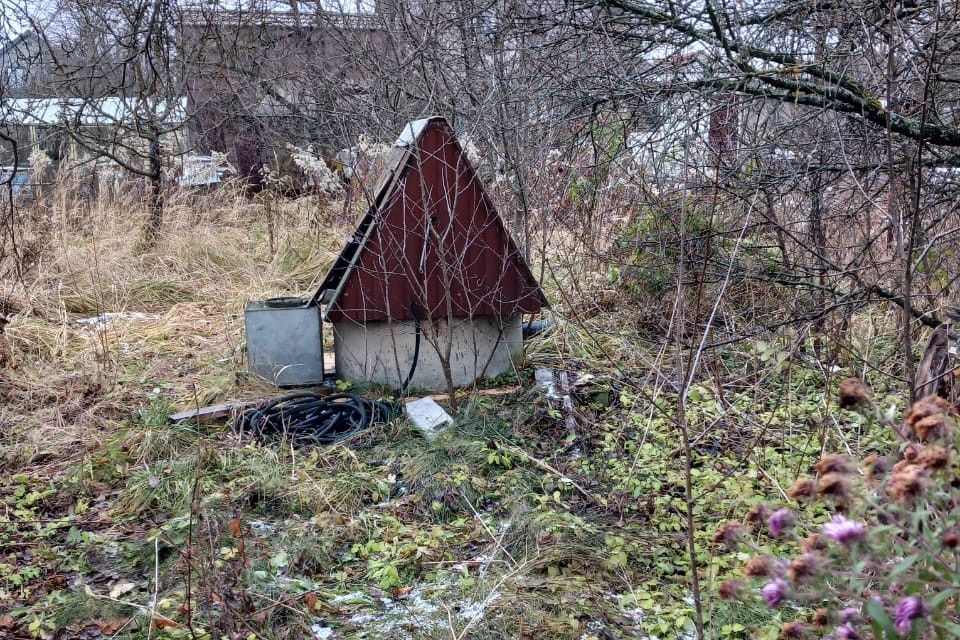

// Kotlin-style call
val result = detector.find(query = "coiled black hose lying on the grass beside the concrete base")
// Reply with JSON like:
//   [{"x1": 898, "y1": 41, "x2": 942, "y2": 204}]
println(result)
[{"x1": 233, "y1": 393, "x2": 399, "y2": 446}]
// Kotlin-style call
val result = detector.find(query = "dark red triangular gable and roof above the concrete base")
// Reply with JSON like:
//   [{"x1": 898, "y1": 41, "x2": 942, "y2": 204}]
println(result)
[{"x1": 317, "y1": 117, "x2": 547, "y2": 323}]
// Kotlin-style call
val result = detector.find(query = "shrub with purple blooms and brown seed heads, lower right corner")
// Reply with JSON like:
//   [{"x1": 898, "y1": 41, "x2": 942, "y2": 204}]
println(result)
[{"x1": 715, "y1": 381, "x2": 960, "y2": 640}]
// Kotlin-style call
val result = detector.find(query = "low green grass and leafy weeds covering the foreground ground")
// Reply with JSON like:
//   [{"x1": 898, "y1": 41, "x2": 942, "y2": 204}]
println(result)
[{"x1": 0, "y1": 318, "x2": 900, "y2": 639}]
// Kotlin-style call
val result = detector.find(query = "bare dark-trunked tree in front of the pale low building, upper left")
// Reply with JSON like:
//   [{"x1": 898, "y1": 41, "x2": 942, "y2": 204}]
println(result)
[{"x1": 6, "y1": 0, "x2": 188, "y2": 242}]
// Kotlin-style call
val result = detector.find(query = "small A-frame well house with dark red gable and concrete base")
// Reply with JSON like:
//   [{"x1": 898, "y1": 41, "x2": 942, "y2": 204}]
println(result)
[{"x1": 317, "y1": 116, "x2": 547, "y2": 390}]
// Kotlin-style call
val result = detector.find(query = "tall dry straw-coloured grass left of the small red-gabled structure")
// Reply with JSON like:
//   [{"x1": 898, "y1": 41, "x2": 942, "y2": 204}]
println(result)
[{"x1": 0, "y1": 185, "x2": 345, "y2": 470}]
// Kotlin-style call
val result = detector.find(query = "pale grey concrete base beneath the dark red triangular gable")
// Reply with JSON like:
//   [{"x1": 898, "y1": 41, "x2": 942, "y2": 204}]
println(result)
[{"x1": 333, "y1": 315, "x2": 523, "y2": 391}]
